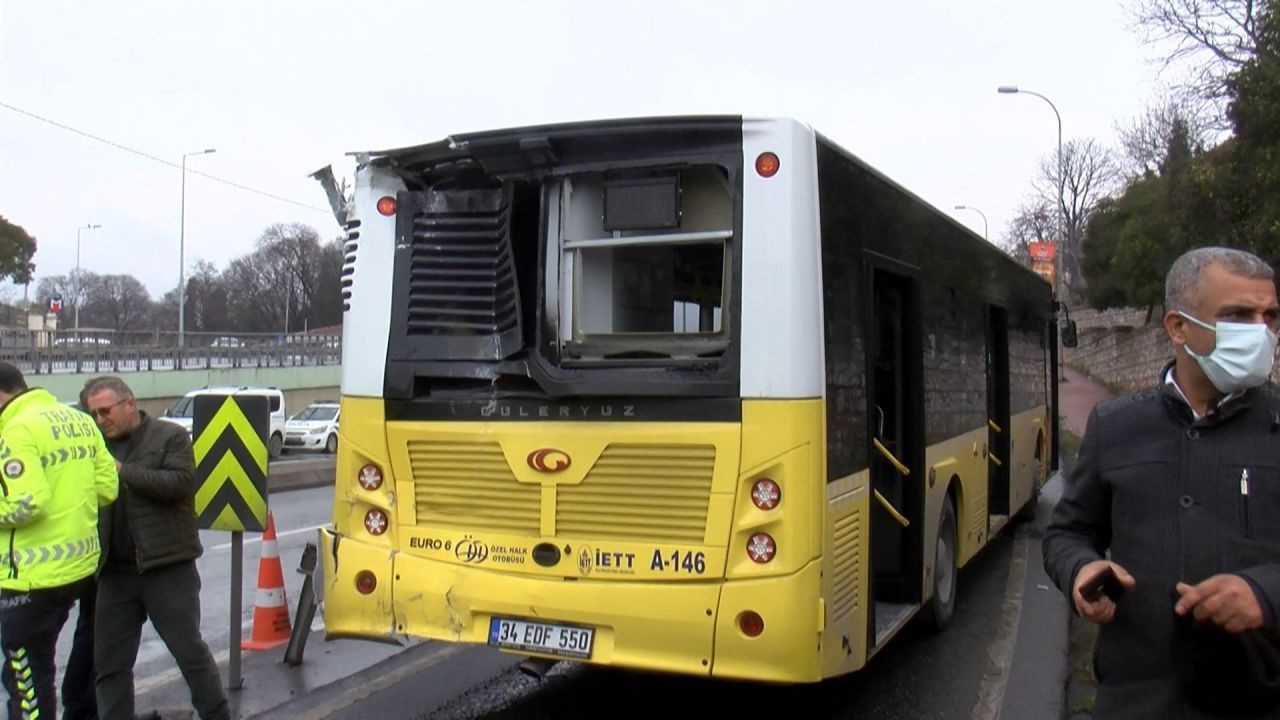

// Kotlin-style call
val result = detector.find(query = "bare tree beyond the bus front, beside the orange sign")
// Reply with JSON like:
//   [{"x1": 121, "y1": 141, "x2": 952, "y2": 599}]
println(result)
[{"x1": 1033, "y1": 137, "x2": 1120, "y2": 302}]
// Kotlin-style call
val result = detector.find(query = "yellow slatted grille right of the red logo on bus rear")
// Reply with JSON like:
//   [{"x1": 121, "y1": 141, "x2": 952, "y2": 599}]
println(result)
[{"x1": 556, "y1": 445, "x2": 716, "y2": 543}]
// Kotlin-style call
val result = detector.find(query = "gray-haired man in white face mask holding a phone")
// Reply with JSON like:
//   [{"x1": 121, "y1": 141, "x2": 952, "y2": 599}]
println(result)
[{"x1": 1043, "y1": 247, "x2": 1280, "y2": 720}]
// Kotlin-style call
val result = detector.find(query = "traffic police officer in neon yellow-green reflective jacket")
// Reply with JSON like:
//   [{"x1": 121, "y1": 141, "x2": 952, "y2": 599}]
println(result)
[{"x1": 0, "y1": 363, "x2": 118, "y2": 720}]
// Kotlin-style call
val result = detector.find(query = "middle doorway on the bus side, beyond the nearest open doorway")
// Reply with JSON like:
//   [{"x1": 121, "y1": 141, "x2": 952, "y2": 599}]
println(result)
[{"x1": 987, "y1": 305, "x2": 1012, "y2": 520}]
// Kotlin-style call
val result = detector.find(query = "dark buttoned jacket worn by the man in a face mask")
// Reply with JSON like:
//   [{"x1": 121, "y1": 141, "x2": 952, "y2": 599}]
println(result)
[{"x1": 1043, "y1": 366, "x2": 1280, "y2": 720}]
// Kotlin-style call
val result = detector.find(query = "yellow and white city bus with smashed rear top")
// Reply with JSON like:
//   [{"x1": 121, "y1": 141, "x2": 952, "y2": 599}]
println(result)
[{"x1": 317, "y1": 117, "x2": 1057, "y2": 683}]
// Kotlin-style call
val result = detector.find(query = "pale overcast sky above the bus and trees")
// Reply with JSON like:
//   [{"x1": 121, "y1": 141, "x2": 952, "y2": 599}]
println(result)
[{"x1": 0, "y1": 0, "x2": 1167, "y2": 297}]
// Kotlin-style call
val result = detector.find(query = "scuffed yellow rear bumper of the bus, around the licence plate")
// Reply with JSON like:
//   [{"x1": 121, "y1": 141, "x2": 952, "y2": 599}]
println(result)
[{"x1": 320, "y1": 529, "x2": 822, "y2": 683}]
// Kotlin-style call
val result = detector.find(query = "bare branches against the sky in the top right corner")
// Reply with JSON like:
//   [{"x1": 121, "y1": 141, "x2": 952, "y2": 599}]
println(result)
[{"x1": 1129, "y1": 0, "x2": 1266, "y2": 107}]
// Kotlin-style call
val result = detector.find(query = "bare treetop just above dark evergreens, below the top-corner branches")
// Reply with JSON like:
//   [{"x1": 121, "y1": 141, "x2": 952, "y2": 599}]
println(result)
[{"x1": 1116, "y1": 96, "x2": 1217, "y2": 179}]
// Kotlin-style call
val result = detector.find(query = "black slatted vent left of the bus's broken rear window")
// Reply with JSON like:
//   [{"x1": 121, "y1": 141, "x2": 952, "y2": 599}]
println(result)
[{"x1": 406, "y1": 188, "x2": 521, "y2": 357}]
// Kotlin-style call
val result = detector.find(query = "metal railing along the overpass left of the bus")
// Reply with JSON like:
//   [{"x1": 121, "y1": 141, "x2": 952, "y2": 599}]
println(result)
[{"x1": 0, "y1": 329, "x2": 342, "y2": 375}]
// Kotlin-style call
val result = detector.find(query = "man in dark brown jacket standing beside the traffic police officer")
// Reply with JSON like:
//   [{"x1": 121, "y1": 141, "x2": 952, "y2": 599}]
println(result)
[{"x1": 84, "y1": 377, "x2": 229, "y2": 720}]
